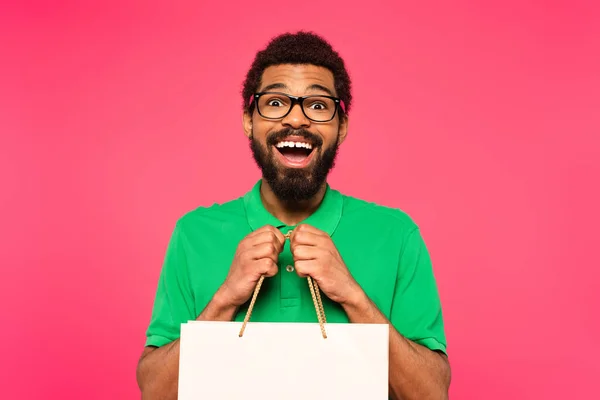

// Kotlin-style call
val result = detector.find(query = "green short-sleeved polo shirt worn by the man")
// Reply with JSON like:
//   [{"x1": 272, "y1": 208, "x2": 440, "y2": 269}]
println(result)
[{"x1": 146, "y1": 180, "x2": 446, "y2": 352}]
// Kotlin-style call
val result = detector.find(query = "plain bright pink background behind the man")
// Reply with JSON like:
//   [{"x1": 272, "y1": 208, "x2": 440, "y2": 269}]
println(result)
[{"x1": 0, "y1": 0, "x2": 600, "y2": 400}]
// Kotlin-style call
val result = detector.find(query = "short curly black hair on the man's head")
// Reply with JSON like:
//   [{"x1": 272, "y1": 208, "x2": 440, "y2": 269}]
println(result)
[{"x1": 242, "y1": 31, "x2": 352, "y2": 114}]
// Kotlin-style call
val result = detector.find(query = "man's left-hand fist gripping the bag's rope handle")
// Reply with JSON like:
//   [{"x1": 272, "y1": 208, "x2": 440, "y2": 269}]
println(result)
[{"x1": 218, "y1": 225, "x2": 285, "y2": 307}]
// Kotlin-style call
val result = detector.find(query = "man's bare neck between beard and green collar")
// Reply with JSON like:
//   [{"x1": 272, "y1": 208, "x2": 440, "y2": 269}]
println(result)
[{"x1": 260, "y1": 179, "x2": 327, "y2": 226}]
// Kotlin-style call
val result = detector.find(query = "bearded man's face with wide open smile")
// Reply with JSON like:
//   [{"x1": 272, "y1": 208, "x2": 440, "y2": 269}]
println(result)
[{"x1": 244, "y1": 64, "x2": 347, "y2": 202}]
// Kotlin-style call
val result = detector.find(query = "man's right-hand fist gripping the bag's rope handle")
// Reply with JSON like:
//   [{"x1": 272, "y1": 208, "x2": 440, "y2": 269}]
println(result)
[{"x1": 290, "y1": 225, "x2": 363, "y2": 305}]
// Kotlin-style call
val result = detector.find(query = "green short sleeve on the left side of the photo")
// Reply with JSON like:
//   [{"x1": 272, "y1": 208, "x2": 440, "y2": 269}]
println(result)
[{"x1": 146, "y1": 223, "x2": 196, "y2": 347}]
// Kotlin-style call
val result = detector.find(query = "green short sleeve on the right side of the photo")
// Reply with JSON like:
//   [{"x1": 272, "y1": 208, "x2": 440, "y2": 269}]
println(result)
[{"x1": 390, "y1": 228, "x2": 447, "y2": 354}]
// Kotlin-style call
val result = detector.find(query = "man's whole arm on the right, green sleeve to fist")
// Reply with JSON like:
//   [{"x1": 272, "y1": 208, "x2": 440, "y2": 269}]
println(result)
[{"x1": 290, "y1": 225, "x2": 450, "y2": 400}]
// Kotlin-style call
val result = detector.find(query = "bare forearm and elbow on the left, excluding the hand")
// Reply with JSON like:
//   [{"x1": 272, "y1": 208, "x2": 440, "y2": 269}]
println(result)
[{"x1": 137, "y1": 292, "x2": 237, "y2": 400}]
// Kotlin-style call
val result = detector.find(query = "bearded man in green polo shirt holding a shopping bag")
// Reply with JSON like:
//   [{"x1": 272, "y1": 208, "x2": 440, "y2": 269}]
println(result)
[{"x1": 137, "y1": 32, "x2": 450, "y2": 399}]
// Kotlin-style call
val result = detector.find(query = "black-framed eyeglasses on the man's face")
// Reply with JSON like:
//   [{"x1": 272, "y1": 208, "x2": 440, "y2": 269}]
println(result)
[{"x1": 250, "y1": 92, "x2": 345, "y2": 122}]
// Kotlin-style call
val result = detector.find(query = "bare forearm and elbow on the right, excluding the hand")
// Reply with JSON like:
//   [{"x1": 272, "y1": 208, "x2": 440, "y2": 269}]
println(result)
[{"x1": 343, "y1": 293, "x2": 450, "y2": 400}]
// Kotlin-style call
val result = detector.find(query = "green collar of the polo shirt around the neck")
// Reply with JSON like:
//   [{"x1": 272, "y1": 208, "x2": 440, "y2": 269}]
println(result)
[{"x1": 244, "y1": 179, "x2": 344, "y2": 236}]
